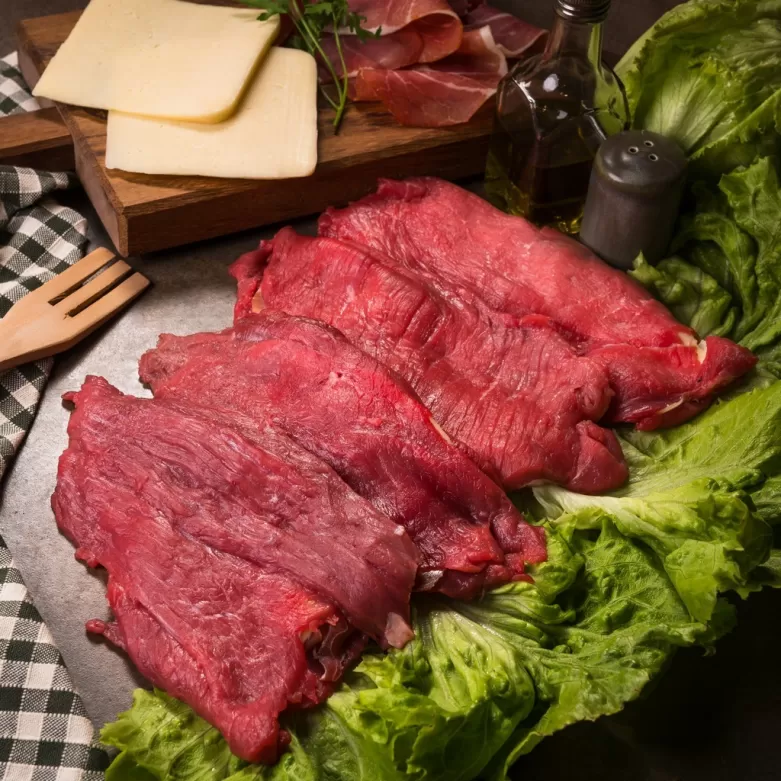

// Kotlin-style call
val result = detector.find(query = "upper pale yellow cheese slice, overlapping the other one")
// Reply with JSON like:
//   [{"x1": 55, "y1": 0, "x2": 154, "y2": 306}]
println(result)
[{"x1": 33, "y1": 0, "x2": 279, "y2": 122}]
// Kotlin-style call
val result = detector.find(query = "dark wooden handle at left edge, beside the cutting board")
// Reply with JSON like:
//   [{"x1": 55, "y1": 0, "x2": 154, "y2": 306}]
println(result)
[{"x1": 0, "y1": 108, "x2": 75, "y2": 171}]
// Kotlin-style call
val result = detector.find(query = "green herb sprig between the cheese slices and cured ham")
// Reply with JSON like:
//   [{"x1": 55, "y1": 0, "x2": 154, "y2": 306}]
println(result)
[{"x1": 242, "y1": 0, "x2": 381, "y2": 131}]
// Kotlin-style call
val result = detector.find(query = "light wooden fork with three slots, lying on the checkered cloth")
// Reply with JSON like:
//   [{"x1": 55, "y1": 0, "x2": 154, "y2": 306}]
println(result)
[{"x1": 0, "y1": 249, "x2": 149, "y2": 371}]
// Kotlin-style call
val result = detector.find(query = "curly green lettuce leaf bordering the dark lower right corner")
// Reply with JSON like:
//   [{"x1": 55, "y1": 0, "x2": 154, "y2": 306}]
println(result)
[{"x1": 478, "y1": 516, "x2": 733, "y2": 781}]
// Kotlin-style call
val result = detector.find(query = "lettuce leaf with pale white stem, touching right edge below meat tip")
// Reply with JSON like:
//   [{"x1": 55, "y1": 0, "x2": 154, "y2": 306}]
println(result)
[{"x1": 534, "y1": 383, "x2": 781, "y2": 622}]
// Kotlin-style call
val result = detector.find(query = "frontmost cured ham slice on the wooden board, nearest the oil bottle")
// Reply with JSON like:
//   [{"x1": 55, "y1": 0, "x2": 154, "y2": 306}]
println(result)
[{"x1": 352, "y1": 26, "x2": 507, "y2": 127}]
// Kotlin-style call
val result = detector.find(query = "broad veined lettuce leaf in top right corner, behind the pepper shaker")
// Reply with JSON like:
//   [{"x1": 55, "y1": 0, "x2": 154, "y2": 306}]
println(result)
[{"x1": 617, "y1": 0, "x2": 781, "y2": 174}]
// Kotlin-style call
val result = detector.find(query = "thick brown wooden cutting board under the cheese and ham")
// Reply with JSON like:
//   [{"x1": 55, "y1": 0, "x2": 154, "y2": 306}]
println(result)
[{"x1": 17, "y1": 12, "x2": 491, "y2": 256}]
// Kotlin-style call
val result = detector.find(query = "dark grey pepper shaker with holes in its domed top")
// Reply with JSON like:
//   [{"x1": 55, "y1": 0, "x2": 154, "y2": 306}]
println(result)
[{"x1": 580, "y1": 130, "x2": 687, "y2": 269}]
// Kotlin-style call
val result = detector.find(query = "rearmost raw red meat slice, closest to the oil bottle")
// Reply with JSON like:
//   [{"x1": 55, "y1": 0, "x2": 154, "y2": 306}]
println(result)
[{"x1": 320, "y1": 178, "x2": 756, "y2": 429}]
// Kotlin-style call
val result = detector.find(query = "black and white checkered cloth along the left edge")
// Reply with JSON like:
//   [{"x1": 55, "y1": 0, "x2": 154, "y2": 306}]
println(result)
[{"x1": 0, "y1": 54, "x2": 108, "y2": 781}]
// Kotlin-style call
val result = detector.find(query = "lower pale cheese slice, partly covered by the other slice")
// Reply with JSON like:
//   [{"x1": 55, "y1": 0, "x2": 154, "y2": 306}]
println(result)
[{"x1": 106, "y1": 46, "x2": 317, "y2": 179}]
